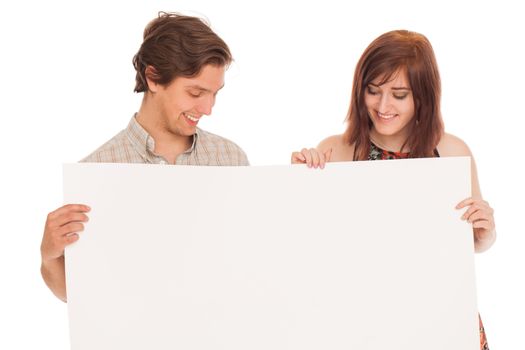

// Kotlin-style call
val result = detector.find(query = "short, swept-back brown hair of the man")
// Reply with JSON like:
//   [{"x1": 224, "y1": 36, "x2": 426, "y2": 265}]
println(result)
[{"x1": 133, "y1": 12, "x2": 232, "y2": 92}]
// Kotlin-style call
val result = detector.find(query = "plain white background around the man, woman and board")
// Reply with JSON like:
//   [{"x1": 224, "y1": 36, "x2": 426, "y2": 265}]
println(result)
[{"x1": 0, "y1": 0, "x2": 525, "y2": 349}]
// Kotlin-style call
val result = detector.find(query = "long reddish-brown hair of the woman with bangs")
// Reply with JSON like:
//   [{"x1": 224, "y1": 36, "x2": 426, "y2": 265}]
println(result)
[{"x1": 344, "y1": 30, "x2": 444, "y2": 160}]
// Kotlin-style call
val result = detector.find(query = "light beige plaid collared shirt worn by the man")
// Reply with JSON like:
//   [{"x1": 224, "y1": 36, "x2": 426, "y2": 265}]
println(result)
[{"x1": 81, "y1": 116, "x2": 249, "y2": 166}]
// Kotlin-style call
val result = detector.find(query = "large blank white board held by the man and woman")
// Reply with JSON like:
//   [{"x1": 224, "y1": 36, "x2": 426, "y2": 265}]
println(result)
[{"x1": 64, "y1": 157, "x2": 479, "y2": 350}]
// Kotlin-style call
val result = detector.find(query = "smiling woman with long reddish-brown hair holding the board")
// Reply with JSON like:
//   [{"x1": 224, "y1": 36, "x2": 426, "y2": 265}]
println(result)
[{"x1": 292, "y1": 30, "x2": 496, "y2": 349}]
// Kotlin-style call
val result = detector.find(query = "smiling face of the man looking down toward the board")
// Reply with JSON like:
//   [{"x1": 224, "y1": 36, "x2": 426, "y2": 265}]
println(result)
[{"x1": 154, "y1": 65, "x2": 225, "y2": 136}]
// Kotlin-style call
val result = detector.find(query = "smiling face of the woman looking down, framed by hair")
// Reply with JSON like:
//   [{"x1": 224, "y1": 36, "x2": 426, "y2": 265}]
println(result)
[{"x1": 365, "y1": 70, "x2": 415, "y2": 143}]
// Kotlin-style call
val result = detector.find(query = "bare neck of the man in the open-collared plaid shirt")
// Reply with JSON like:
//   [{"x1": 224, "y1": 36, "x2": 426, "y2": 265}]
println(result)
[{"x1": 136, "y1": 93, "x2": 193, "y2": 164}]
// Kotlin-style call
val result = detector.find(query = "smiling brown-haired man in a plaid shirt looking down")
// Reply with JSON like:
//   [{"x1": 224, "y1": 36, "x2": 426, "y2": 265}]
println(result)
[{"x1": 41, "y1": 13, "x2": 248, "y2": 302}]
